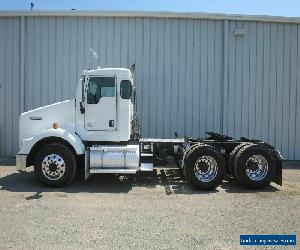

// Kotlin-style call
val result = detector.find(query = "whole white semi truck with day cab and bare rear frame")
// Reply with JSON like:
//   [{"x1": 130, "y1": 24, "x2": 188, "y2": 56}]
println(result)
[{"x1": 16, "y1": 65, "x2": 283, "y2": 190}]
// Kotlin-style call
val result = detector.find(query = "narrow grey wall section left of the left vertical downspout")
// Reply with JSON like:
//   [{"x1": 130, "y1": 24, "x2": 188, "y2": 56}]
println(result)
[{"x1": 0, "y1": 17, "x2": 20, "y2": 156}]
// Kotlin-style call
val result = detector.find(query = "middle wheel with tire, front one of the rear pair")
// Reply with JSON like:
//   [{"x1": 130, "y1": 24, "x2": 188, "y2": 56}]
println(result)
[{"x1": 184, "y1": 144, "x2": 225, "y2": 190}]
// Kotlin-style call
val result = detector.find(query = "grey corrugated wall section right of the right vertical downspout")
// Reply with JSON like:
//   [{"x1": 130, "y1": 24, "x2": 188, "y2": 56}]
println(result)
[{"x1": 223, "y1": 21, "x2": 300, "y2": 160}]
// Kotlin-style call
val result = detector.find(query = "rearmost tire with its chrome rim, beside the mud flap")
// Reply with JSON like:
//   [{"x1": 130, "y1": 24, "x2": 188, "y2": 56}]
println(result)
[{"x1": 234, "y1": 144, "x2": 275, "y2": 189}]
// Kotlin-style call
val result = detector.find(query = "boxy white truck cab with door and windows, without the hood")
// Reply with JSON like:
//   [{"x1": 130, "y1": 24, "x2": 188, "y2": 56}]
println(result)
[{"x1": 75, "y1": 68, "x2": 134, "y2": 142}]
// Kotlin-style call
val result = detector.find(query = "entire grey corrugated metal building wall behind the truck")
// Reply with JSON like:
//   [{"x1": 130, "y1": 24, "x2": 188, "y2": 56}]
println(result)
[{"x1": 0, "y1": 16, "x2": 300, "y2": 160}]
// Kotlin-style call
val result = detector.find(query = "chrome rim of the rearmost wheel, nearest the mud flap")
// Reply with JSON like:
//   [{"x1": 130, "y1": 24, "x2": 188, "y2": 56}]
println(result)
[{"x1": 246, "y1": 155, "x2": 269, "y2": 181}]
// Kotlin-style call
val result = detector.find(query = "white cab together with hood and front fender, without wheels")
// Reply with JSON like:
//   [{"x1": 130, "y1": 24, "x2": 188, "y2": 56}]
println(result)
[{"x1": 19, "y1": 68, "x2": 134, "y2": 155}]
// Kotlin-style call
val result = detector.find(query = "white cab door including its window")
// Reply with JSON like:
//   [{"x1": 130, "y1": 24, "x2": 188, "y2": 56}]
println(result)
[{"x1": 84, "y1": 76, "x2": 117, "y2": 131}]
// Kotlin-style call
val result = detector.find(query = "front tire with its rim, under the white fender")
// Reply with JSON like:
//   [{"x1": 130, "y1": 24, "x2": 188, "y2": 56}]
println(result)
[{"x1": 34, "y1": 143, "x2": 76, "y2": 187}]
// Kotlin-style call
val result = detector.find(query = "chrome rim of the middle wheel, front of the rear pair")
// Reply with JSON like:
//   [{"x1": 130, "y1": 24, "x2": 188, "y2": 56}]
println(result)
[{"x1": 194, "y1": 155, "x2": 218, "y2": 182}]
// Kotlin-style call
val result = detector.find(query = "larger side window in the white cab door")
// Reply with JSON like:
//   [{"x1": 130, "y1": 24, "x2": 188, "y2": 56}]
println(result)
[{"x1": 87, "y1": 77, "x2": 116, "y2": 104}]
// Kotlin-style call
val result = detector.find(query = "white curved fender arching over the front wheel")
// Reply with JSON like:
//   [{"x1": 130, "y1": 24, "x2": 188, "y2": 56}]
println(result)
[{"x1": 18, "y1": 128, "x2": 85, "y2": 155}]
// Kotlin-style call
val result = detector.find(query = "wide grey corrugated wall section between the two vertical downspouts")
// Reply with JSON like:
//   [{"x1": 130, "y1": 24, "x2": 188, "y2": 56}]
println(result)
[{"x1": 25, "y1": 17, "x2": 223, "y2": 141}]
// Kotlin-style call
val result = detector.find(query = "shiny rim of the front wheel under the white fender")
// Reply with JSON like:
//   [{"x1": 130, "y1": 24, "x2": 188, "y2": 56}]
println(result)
[{"x1": 42, "y1": 154, "x2": 66, "y2": 181}]
